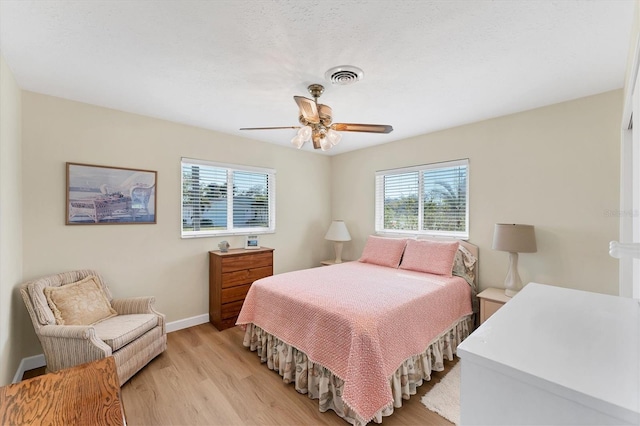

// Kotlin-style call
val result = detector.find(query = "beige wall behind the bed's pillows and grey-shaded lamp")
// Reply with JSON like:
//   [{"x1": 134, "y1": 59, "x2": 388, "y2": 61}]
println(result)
[{"x1": 331, "y1": 90, "x2": 622, "y2": 294}]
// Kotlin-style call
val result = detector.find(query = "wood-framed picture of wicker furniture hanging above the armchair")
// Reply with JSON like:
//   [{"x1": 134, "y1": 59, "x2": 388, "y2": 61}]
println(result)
[{"x1": 66, "y1": 163, "x2": 158, "y2": 225}]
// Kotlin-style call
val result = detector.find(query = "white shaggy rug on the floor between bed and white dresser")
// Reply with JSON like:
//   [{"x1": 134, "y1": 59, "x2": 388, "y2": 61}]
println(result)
[{"x1": 422, "y1": 361, "x2": 460, "y2": 425}]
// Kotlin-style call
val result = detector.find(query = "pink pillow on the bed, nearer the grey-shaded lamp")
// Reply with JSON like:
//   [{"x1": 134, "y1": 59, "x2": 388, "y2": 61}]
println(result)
[{"x1": 400, "y1": 240, "x2": 459, "y2": 277}]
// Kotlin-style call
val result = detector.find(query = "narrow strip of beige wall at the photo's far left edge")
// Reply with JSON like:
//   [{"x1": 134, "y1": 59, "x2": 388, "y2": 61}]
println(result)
[{"x1": 0, "y1": 56, "x2": 25, "y2": 385}]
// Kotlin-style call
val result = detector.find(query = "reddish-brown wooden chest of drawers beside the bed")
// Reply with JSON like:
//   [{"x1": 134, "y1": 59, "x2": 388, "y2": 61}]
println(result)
[{"x1": 209, "y1": 247, "x2": 273, "y2": 330}]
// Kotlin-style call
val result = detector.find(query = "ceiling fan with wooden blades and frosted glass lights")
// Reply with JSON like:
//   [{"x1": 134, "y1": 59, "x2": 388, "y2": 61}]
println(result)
[{"x1": 240, "y1": 84, "x2": 393, "y2": 151}]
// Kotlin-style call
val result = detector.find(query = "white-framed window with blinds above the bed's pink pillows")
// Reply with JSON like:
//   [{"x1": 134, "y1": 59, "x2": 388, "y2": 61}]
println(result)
[{"x1": 376, "y1": 159, "x2": 469, "y2": 238}]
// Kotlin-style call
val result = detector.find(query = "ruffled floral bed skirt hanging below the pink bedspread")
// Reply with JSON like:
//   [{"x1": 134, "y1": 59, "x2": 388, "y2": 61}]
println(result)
[{"x1": 243, "y1": 315, "x2": 473, "y2": 426}]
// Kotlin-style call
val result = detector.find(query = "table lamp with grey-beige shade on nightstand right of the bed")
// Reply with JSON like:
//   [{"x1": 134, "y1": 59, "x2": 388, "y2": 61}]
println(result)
[{"x1": 493, "y1": 223, "x2": 537, "y2": 297}]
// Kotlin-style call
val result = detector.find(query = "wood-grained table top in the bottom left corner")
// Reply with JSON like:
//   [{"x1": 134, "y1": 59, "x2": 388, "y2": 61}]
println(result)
[{"x1": 0, "y1": 357, "x2": 126, "y2": 425}]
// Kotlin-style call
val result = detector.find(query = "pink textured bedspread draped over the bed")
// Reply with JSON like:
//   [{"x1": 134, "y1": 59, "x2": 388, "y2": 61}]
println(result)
[{"x1": 237, "y1": 262, "x2": 472, "y2": 421}]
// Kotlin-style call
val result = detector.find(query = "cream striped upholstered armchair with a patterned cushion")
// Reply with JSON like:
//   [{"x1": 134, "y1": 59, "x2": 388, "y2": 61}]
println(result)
[{"x1": 20, "y1": 269, "x2": 167, "y2": 386}]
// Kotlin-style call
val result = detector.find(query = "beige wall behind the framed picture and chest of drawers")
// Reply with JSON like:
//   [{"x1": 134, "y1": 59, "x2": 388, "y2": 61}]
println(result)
[{"x1": 22, "y1": 91, "x2": 331, "y2": 356}]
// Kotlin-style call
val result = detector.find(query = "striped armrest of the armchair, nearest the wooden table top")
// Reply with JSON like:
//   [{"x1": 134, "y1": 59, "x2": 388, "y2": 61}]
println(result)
[{"x1": 38, "y1": 325, "x2": 113, "y2": 371}]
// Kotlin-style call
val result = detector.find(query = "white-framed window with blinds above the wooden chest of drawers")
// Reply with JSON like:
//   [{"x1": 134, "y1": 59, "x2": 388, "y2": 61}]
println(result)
[{"x1": 182, "y1": 158, "x2": 276, "y2": 238}]
